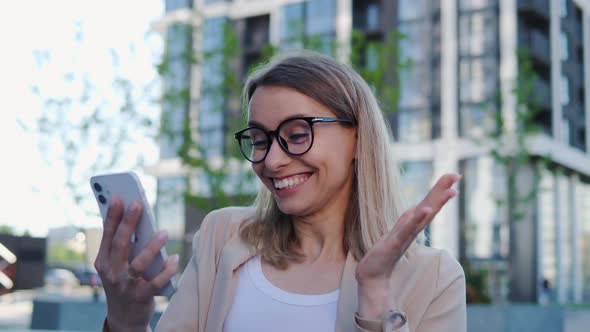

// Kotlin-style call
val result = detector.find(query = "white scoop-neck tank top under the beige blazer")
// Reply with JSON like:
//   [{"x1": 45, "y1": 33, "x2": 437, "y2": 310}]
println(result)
[{"x1": 223, "y1": 256, "x2": 340, "y2": 332}]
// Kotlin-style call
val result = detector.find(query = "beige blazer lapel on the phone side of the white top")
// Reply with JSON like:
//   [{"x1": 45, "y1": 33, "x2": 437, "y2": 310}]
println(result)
[{"x1": 205, "y1": 234, "x2": 255, "y2": 332}]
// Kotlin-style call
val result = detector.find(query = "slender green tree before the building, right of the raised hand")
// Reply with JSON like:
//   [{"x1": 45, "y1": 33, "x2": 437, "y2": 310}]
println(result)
[{"x1": 460, "y1": 49, "x2": 550, "y2": 302}]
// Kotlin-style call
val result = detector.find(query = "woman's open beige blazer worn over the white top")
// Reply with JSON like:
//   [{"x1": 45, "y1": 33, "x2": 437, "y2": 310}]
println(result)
[{"x1": 156, "y1": 207, "x2": 466, "y2": 332}]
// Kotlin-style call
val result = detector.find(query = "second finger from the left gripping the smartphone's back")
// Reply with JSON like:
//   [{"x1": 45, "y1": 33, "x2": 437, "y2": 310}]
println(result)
[{"x1": 110, "y1": 202, "x2": 142, "y2": 267}]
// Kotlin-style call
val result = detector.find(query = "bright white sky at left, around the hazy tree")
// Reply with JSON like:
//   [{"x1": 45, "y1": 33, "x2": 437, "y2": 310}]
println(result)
[{"x1": 0, "y1": 0, "x2": 163, "y2": 236}]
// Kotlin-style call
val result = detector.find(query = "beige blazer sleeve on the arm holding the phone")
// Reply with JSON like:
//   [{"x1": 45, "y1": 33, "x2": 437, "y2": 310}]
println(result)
[{"x1": 155, "y1": 222, "x2": 205, "y2": 332}]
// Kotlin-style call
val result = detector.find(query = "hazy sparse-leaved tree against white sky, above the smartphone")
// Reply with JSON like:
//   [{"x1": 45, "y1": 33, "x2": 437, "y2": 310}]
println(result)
[{"x1": 32, "y1": 26, "x2": 159, "y2": 222}]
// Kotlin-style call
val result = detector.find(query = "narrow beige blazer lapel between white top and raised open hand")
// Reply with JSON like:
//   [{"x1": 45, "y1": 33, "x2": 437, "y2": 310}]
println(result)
[{"x1": 336, "y1": 252, "x2": 358, "y2": 332}]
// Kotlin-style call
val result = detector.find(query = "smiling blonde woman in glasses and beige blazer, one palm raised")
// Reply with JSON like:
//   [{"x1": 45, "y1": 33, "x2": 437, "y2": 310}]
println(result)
[{"x1": 95, "y1": 53, "x2": 466, "y2": 332}]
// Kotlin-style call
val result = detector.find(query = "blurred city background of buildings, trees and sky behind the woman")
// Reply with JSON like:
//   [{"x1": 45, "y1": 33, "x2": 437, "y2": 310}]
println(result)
[{"x1": 0, "y1": 0, "x2": 590, "y2": 331}]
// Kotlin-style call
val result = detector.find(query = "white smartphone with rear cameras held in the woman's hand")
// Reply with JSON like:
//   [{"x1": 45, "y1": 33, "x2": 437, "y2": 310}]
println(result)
[{"x1": 90, "y1": 172, "x2": 176, "y2": 297}]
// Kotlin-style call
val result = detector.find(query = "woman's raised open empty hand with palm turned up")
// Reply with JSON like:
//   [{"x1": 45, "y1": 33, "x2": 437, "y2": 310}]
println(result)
[{"x1": 356, "y1": 174, "x2": 461, "y2": 318}]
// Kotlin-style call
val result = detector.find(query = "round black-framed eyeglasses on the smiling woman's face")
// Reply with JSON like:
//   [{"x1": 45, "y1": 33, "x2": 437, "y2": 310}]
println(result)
[{"x1": 234, "y1": 117, "x2": 353, "y2": 163}]
